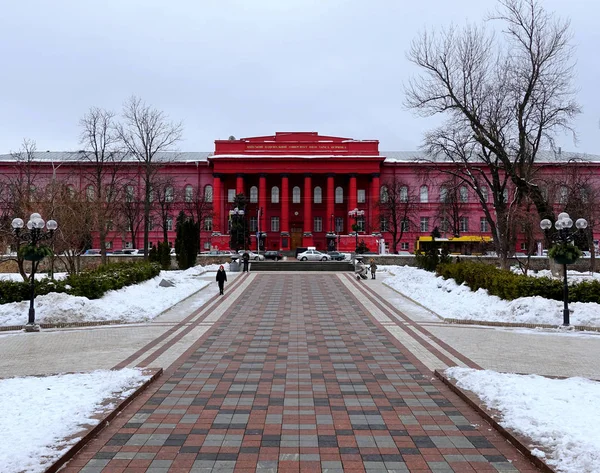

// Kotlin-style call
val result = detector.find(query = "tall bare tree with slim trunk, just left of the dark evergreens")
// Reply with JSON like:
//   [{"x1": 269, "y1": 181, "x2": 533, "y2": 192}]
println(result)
[{"x1": 117, "y1": 97, "x2": 183, "y2": 258}]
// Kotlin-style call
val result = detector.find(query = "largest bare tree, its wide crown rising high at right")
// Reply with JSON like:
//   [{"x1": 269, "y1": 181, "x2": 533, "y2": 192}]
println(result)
[{"x1": 406, "y1": 0, "x2": 580, "y2": 231}]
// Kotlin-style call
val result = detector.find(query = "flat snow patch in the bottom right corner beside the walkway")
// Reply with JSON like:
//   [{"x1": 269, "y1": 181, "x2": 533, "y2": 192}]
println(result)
[{"x1": 445, "y1": 367, "x2": 600, "y2": 473}]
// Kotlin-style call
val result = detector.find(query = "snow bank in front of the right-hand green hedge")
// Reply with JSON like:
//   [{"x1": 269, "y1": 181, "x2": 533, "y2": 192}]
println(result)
[{"x1": 381, "y1": 266, "x2": 600, "y2": 327}]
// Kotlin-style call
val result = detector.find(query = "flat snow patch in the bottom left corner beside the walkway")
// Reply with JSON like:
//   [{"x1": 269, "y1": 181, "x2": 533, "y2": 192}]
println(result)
[{"x1": 0, "y1": 368, "x2": 149, "y2": 473}]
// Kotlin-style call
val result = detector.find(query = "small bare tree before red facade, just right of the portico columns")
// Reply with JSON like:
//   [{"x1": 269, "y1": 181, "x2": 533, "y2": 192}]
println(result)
[{"x1": 379, "y1": 176, "x2": 417, "y2": 253}]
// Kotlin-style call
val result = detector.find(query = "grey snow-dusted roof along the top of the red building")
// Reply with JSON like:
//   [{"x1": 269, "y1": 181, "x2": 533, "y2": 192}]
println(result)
[{"x1": 0, "y1": 150, "x2": 600, "y2": 164}]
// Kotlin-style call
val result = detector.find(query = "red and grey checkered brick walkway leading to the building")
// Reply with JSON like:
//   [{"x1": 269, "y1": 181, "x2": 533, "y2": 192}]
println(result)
[{"x1": 61, "y1": 273, "x2": 537, "y2": 473}]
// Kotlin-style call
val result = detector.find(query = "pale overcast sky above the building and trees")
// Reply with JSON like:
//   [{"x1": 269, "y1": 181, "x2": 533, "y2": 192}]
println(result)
[{"x1": 0, "y1": 0, "x2": 600, "y2": 154}]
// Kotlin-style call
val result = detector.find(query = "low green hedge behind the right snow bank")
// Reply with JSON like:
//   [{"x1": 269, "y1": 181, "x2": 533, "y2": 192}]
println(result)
[{"x1": 437, "y1": 261, "x2": 600, "y2": 303}]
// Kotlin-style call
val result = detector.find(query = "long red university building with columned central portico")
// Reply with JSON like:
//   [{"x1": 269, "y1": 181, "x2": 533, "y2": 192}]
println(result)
[{"x1": 0, "y1": 132, "x2": 600, "y2": 252}]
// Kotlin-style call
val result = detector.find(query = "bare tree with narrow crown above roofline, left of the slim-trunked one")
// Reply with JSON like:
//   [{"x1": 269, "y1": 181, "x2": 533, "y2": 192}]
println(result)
[{"x1": 79, "y1": 107, "x2": 126, "y2": 264}]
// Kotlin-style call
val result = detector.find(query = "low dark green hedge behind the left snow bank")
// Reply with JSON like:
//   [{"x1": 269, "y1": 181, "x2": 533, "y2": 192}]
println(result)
[{"x1": 0, "y1": 261, "x2": 160, "y2": 304}]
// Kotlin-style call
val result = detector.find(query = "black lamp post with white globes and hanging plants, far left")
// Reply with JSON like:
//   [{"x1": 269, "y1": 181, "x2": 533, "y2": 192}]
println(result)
[{"x1": 12, "y1": 213, "x2": 58, "y2": 332}]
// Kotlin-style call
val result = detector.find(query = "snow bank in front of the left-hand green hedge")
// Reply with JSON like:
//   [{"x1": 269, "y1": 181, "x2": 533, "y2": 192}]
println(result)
[{"x1": 0, "y1": 265, "x2": 218, "y2": 326}]
